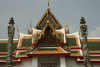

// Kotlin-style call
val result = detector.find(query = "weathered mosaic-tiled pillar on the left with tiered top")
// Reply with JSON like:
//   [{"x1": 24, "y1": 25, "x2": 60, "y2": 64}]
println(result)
[{"x1": 6, "y1": 18, "x2": 15, "y2": 67}]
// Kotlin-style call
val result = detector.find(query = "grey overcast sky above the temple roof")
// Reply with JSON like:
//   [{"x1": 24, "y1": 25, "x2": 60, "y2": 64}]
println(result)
[{"x1": 0, "y1": 0, "x2": 100, "y2": 39}]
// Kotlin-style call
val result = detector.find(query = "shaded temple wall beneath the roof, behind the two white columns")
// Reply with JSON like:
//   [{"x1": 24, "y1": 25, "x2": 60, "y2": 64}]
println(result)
[{"x1": 0, "y1": 56, "x2": 100, "y2": 67}]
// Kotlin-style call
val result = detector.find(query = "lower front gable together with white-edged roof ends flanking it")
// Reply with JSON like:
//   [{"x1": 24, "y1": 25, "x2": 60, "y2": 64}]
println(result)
[{"x1": 31, "y1": 17, "x2": 66, "y2": 47}]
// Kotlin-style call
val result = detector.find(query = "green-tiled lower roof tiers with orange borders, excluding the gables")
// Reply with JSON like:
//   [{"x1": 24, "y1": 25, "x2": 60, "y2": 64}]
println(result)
[{"x1": 0, "y1": 31, "x2": 100, "y2": 63}]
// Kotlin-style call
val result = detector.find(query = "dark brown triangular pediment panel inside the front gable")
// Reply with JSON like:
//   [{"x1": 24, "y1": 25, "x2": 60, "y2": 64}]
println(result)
[{"x1": 37, "y1": 25, "x2": 60, "y2": 47}]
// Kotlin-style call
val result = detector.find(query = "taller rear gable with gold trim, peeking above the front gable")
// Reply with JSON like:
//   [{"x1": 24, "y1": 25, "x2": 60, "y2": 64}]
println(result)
[{"x1": 35, "y1": 9, "x2": 62, "y2": 30}]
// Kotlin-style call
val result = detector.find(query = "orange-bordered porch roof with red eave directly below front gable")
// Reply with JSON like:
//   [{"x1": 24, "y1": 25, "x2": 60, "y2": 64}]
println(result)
[{"x1": 28, "y1": 47, "x2": 70, "y2": 56}]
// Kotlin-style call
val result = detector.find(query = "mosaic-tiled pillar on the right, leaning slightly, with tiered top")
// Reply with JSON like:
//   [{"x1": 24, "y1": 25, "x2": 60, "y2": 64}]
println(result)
[{"x1": 80, "y1": 17, "x2": 93, "y2": 67}]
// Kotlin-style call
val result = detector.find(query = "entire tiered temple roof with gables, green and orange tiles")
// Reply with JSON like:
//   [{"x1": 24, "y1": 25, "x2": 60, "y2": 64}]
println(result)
[{"x1": 0, "y1": 0, "x2": 100, "y2": 67}]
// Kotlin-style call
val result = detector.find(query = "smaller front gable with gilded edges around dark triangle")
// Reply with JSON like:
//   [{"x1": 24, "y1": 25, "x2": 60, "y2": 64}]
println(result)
[{"x1": 33, "y1": 20, "x2": 60, "y2": 46}]
